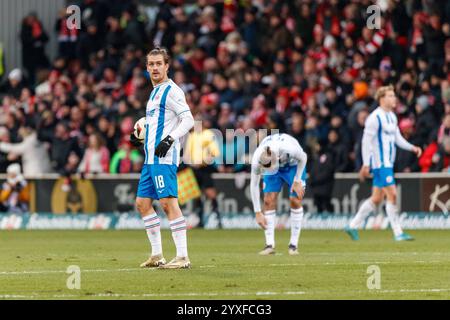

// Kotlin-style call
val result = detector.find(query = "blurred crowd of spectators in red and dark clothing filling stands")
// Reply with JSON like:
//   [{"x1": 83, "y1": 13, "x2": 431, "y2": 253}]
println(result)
[{"x1": 0, "y1": 0, "x2": 450, "y2": 181}]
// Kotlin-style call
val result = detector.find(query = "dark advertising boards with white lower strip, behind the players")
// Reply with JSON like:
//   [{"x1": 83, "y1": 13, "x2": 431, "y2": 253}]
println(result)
[{"x1": 0, "y1": 173, "x2": 450, "y2": 229}]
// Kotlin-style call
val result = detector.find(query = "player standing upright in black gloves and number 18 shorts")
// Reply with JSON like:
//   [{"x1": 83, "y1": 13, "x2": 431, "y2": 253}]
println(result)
[{"x1": 131, "y1": 48, "x2": 194, "y2": 269}]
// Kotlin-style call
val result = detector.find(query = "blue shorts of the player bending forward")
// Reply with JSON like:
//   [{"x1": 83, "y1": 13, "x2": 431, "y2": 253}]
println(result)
[{"x1": 263, "y1": 166, "x2": 306, "y2": 197}]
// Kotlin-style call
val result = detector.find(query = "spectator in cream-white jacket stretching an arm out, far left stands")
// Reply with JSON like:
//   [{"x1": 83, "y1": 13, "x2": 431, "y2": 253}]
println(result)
[{"x1": 0, "y1": 123, "x2": 51, "y2": 176}]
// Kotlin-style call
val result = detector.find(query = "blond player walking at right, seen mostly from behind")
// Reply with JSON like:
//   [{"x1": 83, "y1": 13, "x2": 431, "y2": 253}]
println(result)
[{"x1": 345, "y1": 86, "x2": 422, "y2": 241}]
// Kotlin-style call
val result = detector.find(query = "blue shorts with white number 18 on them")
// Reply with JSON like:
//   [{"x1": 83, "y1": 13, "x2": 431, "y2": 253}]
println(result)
[{"x1": 137, "y1": 164, "x2": 178, "y2": 199}]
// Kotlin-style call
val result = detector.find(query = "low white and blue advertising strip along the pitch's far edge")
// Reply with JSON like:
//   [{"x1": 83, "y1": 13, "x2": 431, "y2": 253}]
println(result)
[{"x1": 0, "y1": 212, "x2": 450, "y2": 230}]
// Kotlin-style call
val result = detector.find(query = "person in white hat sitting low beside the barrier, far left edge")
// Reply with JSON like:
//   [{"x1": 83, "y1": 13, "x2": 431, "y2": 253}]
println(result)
[{"x1": 0, "y1": 163, "x2": 30, "y2": 213}]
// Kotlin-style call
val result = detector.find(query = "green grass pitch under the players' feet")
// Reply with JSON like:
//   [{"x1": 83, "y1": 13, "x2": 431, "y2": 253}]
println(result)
[{"x1": 0, "y1": 230, "x2": 450, "y2": 300}]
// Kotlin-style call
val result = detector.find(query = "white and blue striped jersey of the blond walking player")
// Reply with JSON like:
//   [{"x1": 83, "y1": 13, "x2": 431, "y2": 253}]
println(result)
[{"x1": 362, "y1": 107, "x2": 413, "y2": 169}]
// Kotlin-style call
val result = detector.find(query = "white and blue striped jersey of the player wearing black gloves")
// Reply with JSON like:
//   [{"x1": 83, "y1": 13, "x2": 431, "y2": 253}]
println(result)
[{"x1": 144, "y1": 79, "x2": 191, "y2": 166}]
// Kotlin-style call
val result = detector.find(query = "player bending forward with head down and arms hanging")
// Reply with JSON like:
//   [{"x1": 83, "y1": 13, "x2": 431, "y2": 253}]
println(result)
[{"x1": 250, "y1": 134, "x2": 307, "y2": 255}]
